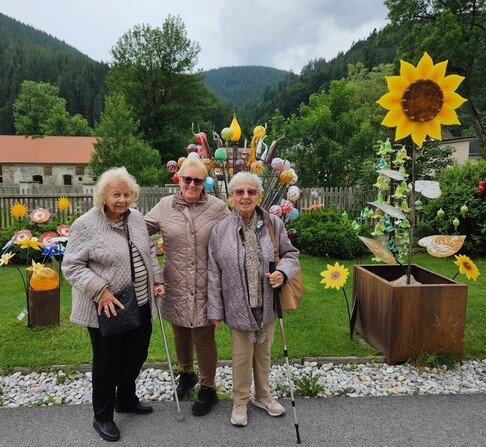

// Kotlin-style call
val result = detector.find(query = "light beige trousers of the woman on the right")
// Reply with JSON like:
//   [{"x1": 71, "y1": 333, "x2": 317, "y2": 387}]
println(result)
[{"x1": 231, "y1": 322, "x2": 275, "y2": 405}]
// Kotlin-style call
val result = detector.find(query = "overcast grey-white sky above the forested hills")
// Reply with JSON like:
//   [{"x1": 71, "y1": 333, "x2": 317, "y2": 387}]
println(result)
[{"x1": 0, "y1": 0, "x2": 387, "y2": 73}]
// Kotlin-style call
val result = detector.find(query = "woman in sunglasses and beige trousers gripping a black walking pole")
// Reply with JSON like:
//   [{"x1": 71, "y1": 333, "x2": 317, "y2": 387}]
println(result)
[{"x1": 208, "y1": 172, "x2": 299, "y2": 425}]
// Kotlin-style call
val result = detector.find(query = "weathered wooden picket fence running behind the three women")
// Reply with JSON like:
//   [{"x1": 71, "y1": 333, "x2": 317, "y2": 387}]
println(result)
[{"x1": 0, "y1": 185, "x2": 374, "y2": 228}]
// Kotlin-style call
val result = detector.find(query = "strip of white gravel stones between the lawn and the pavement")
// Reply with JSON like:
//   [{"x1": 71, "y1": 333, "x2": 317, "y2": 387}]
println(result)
[{"x1": 0, "y1": 359, "x2": 486, "y2": 407}]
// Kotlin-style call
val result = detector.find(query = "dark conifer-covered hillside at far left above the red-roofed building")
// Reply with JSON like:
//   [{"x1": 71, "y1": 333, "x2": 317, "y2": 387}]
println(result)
[{"x1": 0, "y1": 13, "x2": 108, "y2": 134}]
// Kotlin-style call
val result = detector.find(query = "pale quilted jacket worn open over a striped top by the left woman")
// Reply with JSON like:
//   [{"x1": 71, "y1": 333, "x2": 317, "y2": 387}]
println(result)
[{"x1": 62, "y1": 208, "x2": 162, "y2": 327}]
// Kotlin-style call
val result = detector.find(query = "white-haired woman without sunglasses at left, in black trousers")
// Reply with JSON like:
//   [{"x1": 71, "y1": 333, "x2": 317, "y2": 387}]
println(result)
[{"x1": 62, "y1": 168, "x2": 163, "y2": 441}]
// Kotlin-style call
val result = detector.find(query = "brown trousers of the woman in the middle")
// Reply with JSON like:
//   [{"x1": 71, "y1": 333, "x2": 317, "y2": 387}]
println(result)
[{"x1": 172, "y1": 324, "x2": 218, "y2": 388}]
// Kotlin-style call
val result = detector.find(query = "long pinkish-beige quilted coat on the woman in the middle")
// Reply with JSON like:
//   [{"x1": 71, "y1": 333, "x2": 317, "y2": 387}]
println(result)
[{"x1": 145, "y1": 193, "x2": 230, "y2": 327}]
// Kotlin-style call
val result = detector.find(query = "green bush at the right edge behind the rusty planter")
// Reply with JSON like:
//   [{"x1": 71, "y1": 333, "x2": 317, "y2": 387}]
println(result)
[{"x1": 416, "y1": 160, "x2": 486, "y2": 256}]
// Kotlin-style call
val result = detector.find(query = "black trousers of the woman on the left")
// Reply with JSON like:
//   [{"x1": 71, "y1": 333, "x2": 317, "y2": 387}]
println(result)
[{"x1": 88, "y1": 303, "x2": 152, "y2": 422}]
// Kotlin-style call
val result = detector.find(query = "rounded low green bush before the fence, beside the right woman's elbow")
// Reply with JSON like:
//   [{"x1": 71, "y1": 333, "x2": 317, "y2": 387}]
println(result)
[{"x1": 287, "y1": 209, "x2": 366, "y2": 259}]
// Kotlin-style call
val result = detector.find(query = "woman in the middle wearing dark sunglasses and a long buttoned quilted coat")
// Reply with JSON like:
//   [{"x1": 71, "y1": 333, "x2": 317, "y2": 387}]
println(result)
[{"x1": 145, "y1": 159, "x2": 230, "y2": 416}]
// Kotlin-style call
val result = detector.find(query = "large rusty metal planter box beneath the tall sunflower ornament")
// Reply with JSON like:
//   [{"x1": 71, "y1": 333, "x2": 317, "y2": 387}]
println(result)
[{"x1": 353, "y1": 265, "x2": 467, "y2": 364}]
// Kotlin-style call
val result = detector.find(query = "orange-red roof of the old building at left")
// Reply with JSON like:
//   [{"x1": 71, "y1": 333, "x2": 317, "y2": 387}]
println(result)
[{"x1": 0, "y1": 135, "x2": 96, "y2": 164}]
